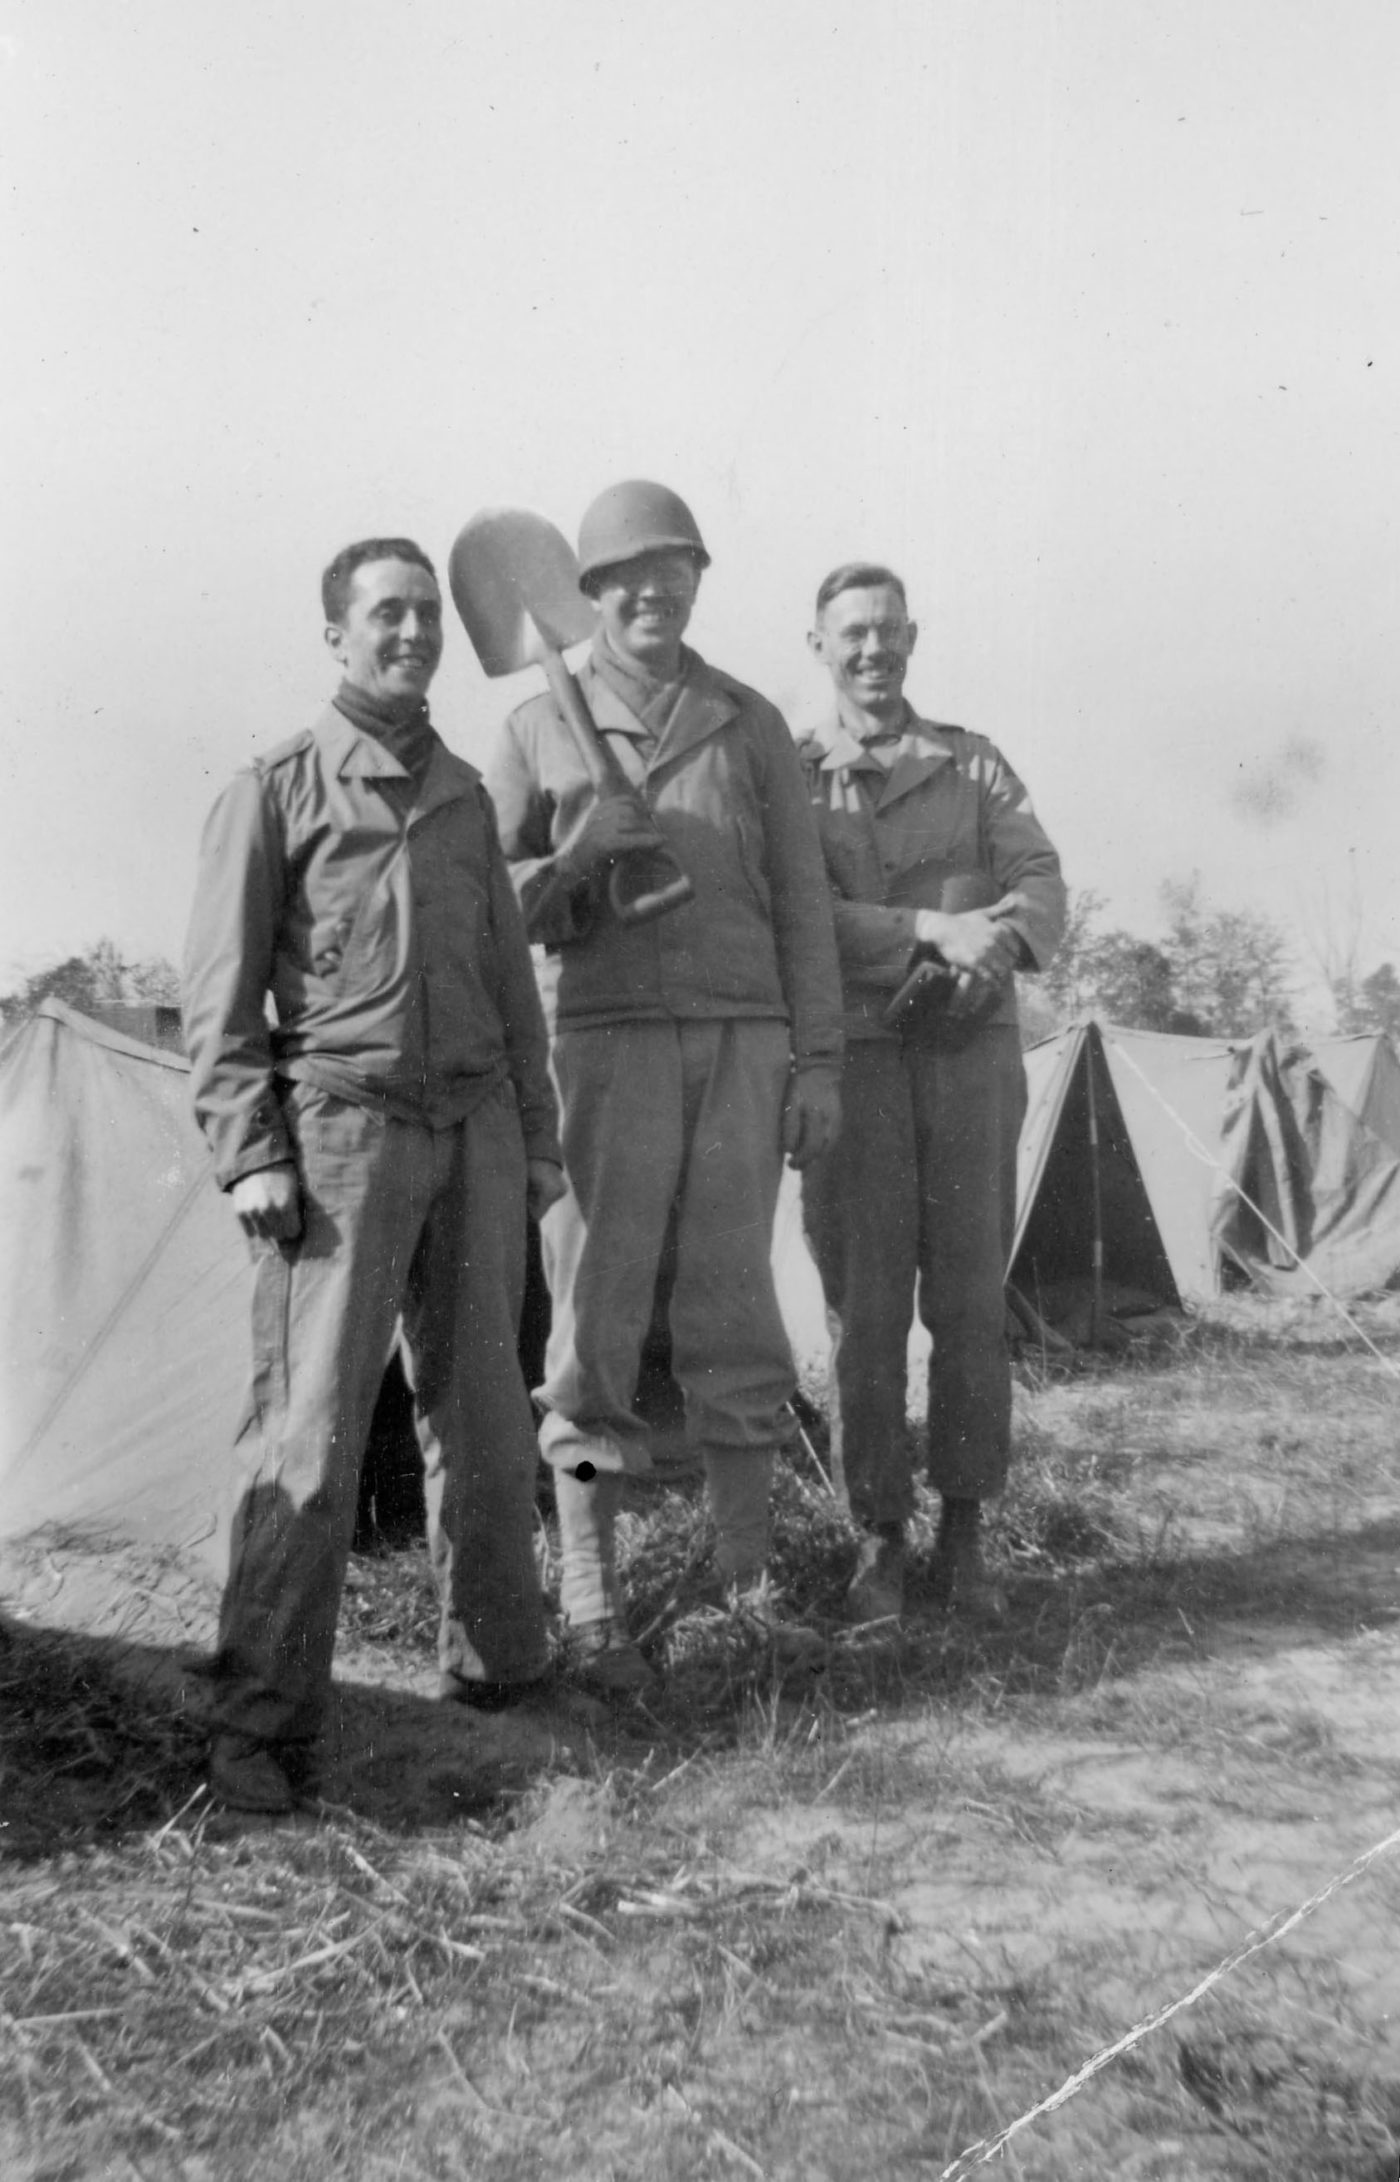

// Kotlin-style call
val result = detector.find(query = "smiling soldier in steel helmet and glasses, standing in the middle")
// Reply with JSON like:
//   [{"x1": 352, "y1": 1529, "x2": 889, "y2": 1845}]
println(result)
[{"x1": 488, "y1": 480, "x2": 842, "y2": 1693}]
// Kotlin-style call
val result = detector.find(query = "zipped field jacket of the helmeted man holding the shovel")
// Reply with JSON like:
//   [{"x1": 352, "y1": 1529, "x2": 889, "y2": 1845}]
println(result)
[{"x1": 486, "y1": 650, "x2": 842, "y2": 1067}]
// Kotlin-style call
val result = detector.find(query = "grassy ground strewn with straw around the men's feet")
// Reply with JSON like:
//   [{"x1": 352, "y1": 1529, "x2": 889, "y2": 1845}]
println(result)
[{"x1": 0, "y1": 1303, "x2": 1400, "y2": 2182}]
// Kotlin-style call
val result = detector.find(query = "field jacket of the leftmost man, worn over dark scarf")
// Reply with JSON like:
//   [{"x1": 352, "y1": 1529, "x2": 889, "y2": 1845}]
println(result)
[{"x1": 183, "y1": 705, "x2": 560, "y2": 1189}]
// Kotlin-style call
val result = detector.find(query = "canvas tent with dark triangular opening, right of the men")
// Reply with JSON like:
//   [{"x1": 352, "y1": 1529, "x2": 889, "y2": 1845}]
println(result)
[{"x1": 1010, "y1": 1019, "x2": 1400, "y2": 1320}]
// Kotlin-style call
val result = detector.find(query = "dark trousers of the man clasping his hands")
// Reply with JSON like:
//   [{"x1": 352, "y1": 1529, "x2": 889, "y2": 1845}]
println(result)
[{"x1": 802, "y1": 1023, "x2": 1025, "y2": 1525}]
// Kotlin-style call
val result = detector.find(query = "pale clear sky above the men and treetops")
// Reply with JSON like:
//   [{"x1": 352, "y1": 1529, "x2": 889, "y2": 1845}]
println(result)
[{"x1": 0, "y1": 0, "x2": 1400, "y2": 1021}]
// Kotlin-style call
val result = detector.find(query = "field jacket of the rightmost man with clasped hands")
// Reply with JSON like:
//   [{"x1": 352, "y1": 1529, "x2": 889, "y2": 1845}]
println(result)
[{"x1": 798, "y1": 711, "x2": 1064, "y2": 1039}]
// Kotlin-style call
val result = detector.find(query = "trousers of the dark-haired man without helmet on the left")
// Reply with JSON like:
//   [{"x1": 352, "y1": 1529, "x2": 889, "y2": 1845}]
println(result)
[{"x1": 214, "y1": 1084, "x2": 547, "y2": 1743}]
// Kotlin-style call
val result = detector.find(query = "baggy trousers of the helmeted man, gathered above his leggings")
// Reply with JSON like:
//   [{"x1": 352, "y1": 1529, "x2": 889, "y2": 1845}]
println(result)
[{"x1": 539, "y1": 1019, "x2": 794, "y2": 1471}]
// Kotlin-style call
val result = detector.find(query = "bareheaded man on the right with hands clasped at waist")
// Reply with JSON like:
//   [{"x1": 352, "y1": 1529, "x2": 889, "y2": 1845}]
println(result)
[{"x1": 802, "y1": 563, "x2": 1064, "y2": 1621}]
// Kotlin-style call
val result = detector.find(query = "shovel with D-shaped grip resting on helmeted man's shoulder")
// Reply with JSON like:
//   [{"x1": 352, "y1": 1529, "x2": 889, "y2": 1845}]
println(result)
[{"x1": 447, "y1": 508, "x2": 696, "y2": 925}]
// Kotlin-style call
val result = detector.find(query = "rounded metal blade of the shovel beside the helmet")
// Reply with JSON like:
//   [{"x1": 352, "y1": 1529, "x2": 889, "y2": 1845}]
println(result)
[{"x1": 447, "y1": 508, "x2": 598, "y2": 676}]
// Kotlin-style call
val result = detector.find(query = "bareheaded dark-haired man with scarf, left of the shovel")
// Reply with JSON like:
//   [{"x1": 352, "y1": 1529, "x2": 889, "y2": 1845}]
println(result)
[{"x1": 185, "y1": 539, "x2": 563, "y2": 1811}]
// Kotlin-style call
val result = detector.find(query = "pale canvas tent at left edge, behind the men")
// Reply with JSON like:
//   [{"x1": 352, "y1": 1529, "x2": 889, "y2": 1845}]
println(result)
[{"x1": 0, "y1": 1002, "x2": 824, "y2": 1595}]
